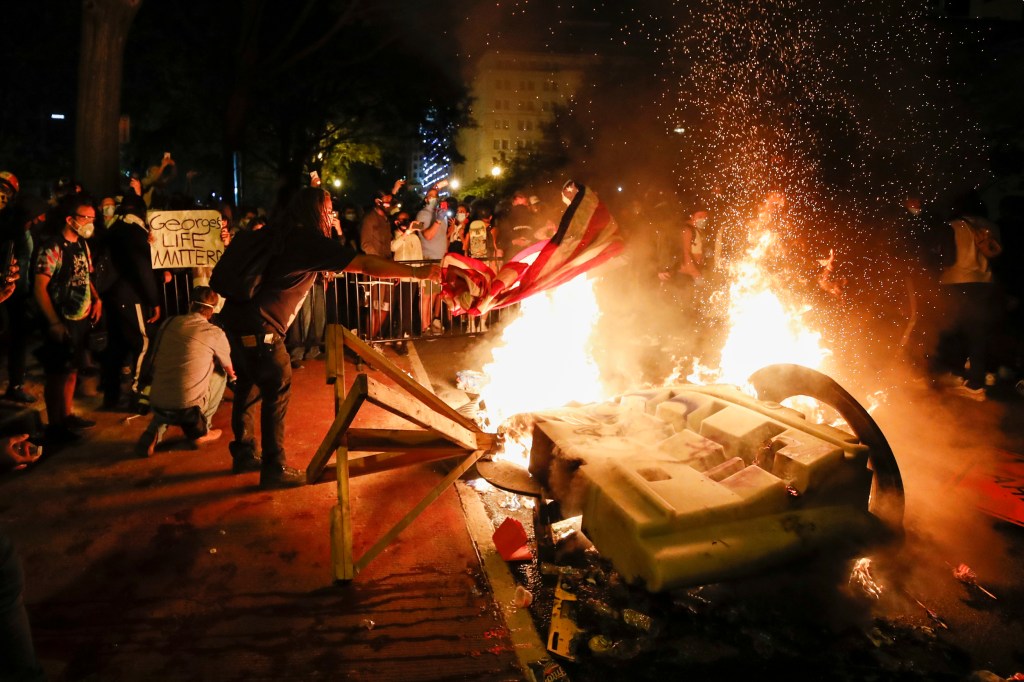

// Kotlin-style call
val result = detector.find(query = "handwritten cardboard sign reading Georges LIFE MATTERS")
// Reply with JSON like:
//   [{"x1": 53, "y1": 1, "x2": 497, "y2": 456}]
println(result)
[{"x1": 145, "y1": 210, "x2": 224, "y2": 270}]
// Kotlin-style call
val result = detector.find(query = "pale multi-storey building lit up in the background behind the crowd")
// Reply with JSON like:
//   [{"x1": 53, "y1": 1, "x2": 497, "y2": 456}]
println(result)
[{"x1": 456, "y1": 51, "x2": 597, "y2": 182}]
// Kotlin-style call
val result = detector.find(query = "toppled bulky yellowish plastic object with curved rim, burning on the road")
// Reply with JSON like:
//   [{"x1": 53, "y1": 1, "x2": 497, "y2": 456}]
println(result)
[{"x1": 520, "y1": 366, "x2": 903, "y2": 591}]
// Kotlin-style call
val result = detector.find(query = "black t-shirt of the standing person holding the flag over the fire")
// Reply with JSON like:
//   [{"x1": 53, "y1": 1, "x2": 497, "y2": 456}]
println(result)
[{"x1": 221, "y1": 227, "x2": 356, "y2": 335}]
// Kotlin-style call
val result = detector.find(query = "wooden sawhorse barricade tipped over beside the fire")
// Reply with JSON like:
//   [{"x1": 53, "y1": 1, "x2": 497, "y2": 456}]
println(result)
[{"x1": 306, "y1": 325, "x2": 498, "y2": 581}]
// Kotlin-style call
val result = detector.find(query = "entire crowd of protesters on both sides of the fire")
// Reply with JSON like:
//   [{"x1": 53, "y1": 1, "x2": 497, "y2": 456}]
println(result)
[{"x1": 0, "y1": 148, "x2": 1022, "y2": 668}]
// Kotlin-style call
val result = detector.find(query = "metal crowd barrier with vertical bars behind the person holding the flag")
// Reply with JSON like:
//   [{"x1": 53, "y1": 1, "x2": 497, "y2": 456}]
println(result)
[{"x1": 163, "y1": 259, "x2": 518, "y2": 343}]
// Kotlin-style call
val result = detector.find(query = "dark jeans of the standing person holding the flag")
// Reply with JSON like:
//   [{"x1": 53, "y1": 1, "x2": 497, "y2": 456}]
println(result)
[{"x1": 227, "y1": 332, "x2": 292, "y2": 471}]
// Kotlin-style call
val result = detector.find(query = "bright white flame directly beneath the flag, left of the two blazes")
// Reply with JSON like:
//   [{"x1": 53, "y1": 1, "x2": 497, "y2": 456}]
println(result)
[{"x1": 480, "y1": 274, "x2": 608, "y2": 462}]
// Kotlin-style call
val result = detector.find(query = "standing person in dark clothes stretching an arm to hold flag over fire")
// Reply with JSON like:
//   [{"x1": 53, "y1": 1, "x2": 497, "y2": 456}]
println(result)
[{"x1": 220, "y1": 187, "x2": 440, "y2": 488}]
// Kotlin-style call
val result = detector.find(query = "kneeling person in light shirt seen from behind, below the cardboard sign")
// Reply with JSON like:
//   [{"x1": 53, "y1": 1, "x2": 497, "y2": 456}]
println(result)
[{"x1": 135, "y1": 287, "x2": 234, "y2": 457}]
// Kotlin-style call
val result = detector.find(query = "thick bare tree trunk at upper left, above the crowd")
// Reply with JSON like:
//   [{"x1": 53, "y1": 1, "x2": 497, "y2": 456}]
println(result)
[{"x1": 75, "y1": 0, "x2": 142, "y2": 197}]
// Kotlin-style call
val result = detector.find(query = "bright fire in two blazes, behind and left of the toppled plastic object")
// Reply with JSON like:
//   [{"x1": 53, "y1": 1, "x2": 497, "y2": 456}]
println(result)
[{"x1": 480, "y1": 204, "x2": 829, "y2": 463}]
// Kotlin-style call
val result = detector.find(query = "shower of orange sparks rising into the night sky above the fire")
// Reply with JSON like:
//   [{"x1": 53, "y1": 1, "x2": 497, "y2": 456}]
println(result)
[{"x1": 633, "y1": 0, "x2": 982, "y2": 368}]
